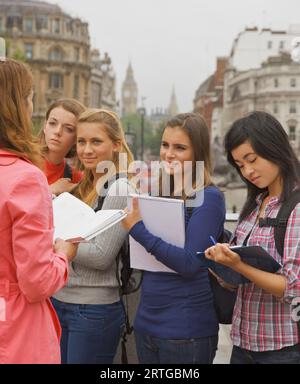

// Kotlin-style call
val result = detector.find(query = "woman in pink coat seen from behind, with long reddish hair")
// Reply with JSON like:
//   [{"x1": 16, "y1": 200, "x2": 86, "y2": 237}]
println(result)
[{"x1": 0, "y1": 59, "x2": 76, "y2": 364}]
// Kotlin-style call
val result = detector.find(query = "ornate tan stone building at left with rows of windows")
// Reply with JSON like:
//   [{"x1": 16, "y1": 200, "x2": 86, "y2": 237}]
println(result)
[{"x1": 0, "y1": 0, "x2": 114, "y2": 122}]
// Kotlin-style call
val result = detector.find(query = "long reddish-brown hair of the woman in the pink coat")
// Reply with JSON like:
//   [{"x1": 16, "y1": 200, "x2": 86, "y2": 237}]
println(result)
[{"x1": 0, "y1": 59, "x2": 42, "y2": 167}]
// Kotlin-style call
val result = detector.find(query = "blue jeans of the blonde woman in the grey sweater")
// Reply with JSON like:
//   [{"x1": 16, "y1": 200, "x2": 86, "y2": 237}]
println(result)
[{"x1": 51, "y1": 298, "x2": 125, "y2": 364}]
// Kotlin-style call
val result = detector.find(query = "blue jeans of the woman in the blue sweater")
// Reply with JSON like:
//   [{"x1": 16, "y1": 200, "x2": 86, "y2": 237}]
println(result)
[{"x1": 134, "y1": 331, "x2": 218, "y2": 364}]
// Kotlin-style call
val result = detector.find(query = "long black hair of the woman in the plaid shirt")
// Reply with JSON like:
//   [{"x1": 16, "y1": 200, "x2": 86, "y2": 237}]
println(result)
[{"x1": 225, "y1": 111, "x2": 300, "y2": 220}]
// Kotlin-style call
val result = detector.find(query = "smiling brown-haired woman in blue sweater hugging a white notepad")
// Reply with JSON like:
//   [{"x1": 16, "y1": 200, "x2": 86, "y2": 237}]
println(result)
[{"x1": 123, "y1": 113, "x2": 225, "y2": 364}]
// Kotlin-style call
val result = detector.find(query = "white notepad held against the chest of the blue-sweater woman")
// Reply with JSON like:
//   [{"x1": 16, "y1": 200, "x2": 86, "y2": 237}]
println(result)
[{"x1": 128, "y1": 195, "x2": 185, "y2": 272}]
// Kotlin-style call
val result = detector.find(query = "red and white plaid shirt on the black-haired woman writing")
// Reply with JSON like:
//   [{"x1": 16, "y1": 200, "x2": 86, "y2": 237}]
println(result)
[{"x1": 231, "y1": 194, "x2": 300, "y2": 352}]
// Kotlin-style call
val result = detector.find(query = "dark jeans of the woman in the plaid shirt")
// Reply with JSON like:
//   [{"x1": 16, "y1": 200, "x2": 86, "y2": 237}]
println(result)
[{"x1": 230, "y1": 344, "x2": 300, "y2": 364}]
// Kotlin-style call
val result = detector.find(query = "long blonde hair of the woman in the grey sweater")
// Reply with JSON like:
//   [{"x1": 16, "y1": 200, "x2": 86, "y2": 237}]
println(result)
[{"x1": 76, "y1": 109, "x2": 133, "y2": 205}]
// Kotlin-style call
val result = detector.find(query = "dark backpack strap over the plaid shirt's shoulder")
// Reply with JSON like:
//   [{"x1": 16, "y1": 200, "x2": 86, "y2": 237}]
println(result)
[{"x1": 259, "y1": 189, "x2": 300, "y2": 257}]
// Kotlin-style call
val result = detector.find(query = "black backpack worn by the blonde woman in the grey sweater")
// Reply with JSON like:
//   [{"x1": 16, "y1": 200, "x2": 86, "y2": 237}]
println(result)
[{"x1": 95, "y1": 174, "x2": 143, "y2": 364}]
